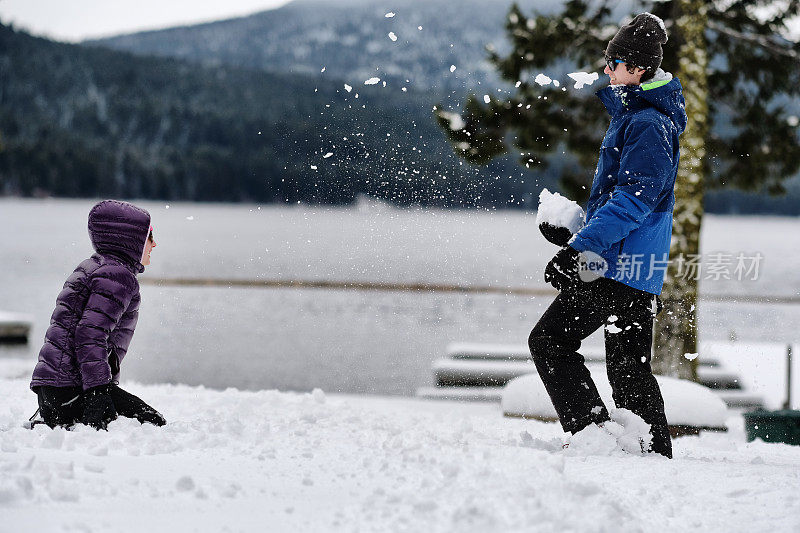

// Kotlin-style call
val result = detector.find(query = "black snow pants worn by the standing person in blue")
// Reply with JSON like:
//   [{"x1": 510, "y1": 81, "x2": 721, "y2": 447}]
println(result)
[{"x1": 528, "y1": 278, "x2": 672, "y2": 457}]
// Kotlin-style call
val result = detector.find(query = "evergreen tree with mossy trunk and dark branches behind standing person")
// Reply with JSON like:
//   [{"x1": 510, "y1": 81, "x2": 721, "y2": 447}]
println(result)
[{"x1": 437, "y1": 0, "x2": 800, "y2": 378}]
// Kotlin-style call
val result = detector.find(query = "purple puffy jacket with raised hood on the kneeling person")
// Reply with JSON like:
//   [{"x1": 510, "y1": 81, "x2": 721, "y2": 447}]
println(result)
[{"x1": 31, "y1": 200, "x2": 150, "y2": 390}]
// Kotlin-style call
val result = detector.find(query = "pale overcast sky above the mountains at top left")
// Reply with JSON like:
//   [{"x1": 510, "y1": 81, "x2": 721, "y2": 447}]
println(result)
[{"x1": 0, "y1": 0, "x2": 289, "y2": 42}]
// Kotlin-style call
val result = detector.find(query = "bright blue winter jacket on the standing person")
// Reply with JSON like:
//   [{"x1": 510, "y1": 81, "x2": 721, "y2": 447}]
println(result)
[{"x1": 570, "y1": 78, "x2": 686, "y2": 294}]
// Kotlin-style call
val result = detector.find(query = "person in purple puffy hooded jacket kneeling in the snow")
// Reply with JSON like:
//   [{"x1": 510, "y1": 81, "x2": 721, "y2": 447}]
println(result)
[{"x1": 31, "y1": 200, "x2": 166, "y2": 429}]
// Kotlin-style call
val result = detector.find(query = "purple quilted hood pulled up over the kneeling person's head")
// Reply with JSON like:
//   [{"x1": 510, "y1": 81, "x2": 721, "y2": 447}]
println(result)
[{"x1": 89, "y1": 200, "x2": 150, "y2": 273}]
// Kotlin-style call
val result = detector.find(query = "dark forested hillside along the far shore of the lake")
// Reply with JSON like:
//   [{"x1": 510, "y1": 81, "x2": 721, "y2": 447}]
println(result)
[{"x1": 0, "y1": 26, "x2": 536, "y2": 207}]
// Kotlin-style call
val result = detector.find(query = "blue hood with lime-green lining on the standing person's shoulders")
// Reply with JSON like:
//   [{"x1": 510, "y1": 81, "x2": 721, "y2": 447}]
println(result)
[{"x1": 596, "y1": 76, "x2": 687, "y2": 134}]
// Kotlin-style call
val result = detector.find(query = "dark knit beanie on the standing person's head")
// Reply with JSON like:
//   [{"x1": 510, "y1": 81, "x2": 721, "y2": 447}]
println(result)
[{"x1": 606, "y1": 13, "x2": 667, "y2": 71}]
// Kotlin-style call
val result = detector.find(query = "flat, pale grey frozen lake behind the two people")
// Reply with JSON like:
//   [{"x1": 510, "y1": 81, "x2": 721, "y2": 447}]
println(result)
[{"x1": 0, "y1": 199, "x2": 800, "y2": 394}]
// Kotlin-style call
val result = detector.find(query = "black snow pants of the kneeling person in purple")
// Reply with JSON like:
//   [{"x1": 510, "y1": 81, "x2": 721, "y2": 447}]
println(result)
[{"x1": 35, "y1": 385, "x2": 166, "y2": 428}]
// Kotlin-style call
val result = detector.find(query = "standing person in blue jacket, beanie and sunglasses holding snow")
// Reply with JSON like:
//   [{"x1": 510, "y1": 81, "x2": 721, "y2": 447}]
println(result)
[{"x1": 528, "y1": 13, "x2": 686, "y2": 457}]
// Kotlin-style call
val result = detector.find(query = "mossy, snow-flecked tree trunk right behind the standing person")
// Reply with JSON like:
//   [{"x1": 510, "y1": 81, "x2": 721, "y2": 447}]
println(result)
[{"x1": 653, "y1": 0, "x2": 708, "y2": 381}]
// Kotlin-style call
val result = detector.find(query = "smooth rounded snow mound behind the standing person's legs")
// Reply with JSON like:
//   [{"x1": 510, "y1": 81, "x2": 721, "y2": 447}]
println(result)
[{"x1": 500, "y1": 367, "x2": 729, "y2": 428}]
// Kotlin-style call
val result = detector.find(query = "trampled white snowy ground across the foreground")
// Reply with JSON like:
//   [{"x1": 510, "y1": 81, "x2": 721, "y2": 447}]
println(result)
[{"x1": 0, "y1": 361, "x2": 800, "y2": 533}]
